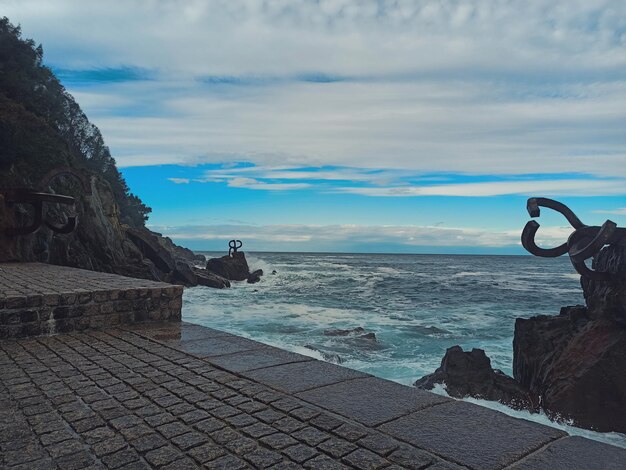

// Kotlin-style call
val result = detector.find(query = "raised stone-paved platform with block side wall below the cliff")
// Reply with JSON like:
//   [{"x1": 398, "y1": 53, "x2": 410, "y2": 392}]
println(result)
[{"x1": 0, "y1": 263, "x2": 183, "y2": 338}]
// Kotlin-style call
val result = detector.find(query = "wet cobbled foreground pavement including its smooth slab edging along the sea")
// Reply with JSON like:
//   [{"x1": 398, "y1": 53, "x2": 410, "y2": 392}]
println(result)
[{"x1": 0, "y1": 323, "x2": 626, "y2": 470}]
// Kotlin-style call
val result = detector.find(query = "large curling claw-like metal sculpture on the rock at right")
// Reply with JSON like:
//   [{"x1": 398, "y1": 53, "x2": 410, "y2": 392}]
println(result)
[{"x1": 522, "y1": 197, "x2": 626, "y2": 281}]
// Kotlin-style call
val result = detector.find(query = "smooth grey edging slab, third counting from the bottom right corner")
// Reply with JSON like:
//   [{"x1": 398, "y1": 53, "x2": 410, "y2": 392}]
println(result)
[{"x1": 297, "y1": 377, "x2": 450, "y2": 426}]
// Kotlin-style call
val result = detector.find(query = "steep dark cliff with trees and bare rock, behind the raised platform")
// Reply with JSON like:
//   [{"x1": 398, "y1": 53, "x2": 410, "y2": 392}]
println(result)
[{"x1": 0, "y1": 18, "x2": 204, "y2": 284}]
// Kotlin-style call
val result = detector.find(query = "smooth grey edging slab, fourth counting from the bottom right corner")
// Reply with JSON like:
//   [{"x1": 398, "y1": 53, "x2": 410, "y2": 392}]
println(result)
[{"x1": 245, "y1": 361, "x2": 367, "y2": 393}]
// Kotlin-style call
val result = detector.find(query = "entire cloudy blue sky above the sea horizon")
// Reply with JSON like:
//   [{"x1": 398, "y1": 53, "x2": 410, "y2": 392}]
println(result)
[{"x1": 0, "y1": 0, "x2": 626, "y2": 254}]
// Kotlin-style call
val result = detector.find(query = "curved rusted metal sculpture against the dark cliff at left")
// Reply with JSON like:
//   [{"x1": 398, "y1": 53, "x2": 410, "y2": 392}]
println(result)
[{"x1": 0, "y1": 167, "x2": 91, "y2": 236}]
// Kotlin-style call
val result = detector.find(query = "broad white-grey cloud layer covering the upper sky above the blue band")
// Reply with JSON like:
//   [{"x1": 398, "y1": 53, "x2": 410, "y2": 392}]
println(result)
[{"x1": 6, "y1": 0, "x2": 626, "y2": 185}]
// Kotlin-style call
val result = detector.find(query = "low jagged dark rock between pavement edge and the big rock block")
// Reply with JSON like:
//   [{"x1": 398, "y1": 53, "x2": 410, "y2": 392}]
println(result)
[{"x1": 414, "y1": 346, "x2": 538, "y2": 410}]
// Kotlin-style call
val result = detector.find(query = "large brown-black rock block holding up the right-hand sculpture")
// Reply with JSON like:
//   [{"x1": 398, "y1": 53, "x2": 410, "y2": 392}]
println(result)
[{"x1": 513, "y1": 246, "x2": 626, "y2": 433}]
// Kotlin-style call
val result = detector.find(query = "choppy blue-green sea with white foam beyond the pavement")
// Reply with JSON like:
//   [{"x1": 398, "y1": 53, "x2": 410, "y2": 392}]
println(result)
[{"x1": 183, "y1": 253, "x2": 626, "y2": 447}]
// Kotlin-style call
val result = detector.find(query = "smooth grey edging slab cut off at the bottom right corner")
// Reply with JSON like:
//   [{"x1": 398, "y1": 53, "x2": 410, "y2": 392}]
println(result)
[{"x1": 512, "y1": 436, "x2": 626, "y2": 470}]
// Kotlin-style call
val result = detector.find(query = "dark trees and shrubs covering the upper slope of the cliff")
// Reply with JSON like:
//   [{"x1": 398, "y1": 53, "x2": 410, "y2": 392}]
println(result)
[{"x1": 0, "y1": 17, "x2": 151, "y2": 228}]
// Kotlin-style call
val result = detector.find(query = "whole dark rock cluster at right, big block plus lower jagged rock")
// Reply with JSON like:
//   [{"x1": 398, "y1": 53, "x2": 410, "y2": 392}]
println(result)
[{"x1": 416, "y1": 245, "x2": 626, "y2": 433}]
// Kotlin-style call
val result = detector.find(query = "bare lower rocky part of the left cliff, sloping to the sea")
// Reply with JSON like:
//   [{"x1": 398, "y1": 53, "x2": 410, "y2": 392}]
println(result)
[{"x1": 0, "y1": 169, "x2": 227, "y2": 287}]
